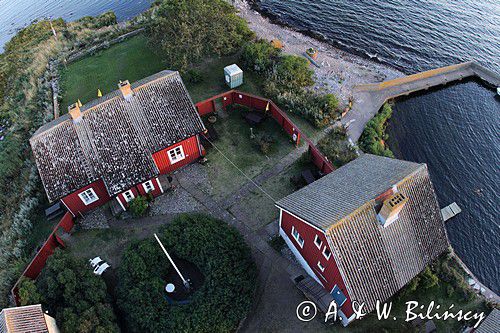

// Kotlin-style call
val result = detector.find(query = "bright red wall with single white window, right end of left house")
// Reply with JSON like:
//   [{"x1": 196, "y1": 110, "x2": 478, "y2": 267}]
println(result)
[{"x1": 153, "y1": 136, "x2": 201, "y2": 174}]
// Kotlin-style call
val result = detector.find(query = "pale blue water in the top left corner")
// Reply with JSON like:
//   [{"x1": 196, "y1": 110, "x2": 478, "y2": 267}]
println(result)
[{"x1": 0, "y1": 0, "x2": 153, "y2": 52}]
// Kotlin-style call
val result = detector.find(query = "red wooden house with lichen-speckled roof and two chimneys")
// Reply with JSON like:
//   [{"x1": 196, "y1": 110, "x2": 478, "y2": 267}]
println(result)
[{"x1": 30, "y1": 71, "x2": 205, "y2": 216}]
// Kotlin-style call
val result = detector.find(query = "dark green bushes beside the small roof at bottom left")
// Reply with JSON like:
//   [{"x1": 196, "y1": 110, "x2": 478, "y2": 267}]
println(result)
[{"x1": 19, "y1": 250, "x2": 119, "y2": 333}]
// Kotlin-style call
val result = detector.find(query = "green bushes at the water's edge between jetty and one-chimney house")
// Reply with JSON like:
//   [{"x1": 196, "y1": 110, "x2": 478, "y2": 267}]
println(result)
[{"x1": 358, "y1": 103, "x2": 394, "y2": 157}]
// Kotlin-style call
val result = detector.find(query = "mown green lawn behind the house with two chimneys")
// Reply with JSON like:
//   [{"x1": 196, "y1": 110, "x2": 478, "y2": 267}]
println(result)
[{"x1": 61, "y1": 35, "x2": 167, "y2": 113}]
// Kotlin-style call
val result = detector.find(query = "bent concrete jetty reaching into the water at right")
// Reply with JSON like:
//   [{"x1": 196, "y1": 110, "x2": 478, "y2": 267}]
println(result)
[{"x1": 342, "y1": 61, "x2": 500, "y2": 142}]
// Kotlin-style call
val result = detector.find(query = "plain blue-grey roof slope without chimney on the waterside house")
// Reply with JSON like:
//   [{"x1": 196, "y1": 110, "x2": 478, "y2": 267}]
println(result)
[{"x1": 277, "y1": 154, "x2": 425, "y2": 230}]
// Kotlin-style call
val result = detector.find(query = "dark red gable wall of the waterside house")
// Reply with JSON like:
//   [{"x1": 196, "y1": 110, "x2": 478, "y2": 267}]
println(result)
[{"x1": 280, "y1": 210, "x2": 353, "y2": 317}]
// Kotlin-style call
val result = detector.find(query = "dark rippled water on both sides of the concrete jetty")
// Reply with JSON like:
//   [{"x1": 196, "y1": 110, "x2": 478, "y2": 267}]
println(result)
[{"x1": 261, "y1": 0, "x2": 500, "y2": 293}]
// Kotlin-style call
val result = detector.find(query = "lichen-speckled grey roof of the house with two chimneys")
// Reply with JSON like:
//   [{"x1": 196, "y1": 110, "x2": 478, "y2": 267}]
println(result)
[{"x1": 30, "y1": 71, "x2": 205, "y2": 201}]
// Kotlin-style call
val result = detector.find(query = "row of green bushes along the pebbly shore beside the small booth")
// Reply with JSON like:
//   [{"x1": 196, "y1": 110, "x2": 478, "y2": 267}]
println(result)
[{"x1": 240, "y1": 40, "x2": 340, "y2": 128}]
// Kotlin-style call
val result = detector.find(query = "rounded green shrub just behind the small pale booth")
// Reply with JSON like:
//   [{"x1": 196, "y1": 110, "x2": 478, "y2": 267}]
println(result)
[{"x1": 240, "y1": 39, "x2": 281, "y2": 73}]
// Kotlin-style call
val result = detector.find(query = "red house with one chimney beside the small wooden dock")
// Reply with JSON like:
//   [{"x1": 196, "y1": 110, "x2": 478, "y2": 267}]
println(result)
[{"x1": 277, "y1": 154, "x2": 448, "y2": 325}]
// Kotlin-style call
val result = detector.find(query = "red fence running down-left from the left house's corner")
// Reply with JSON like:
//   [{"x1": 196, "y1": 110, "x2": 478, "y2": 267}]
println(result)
[{"x1": 11, "y1": 212, "x2": 75, "y2": 306}]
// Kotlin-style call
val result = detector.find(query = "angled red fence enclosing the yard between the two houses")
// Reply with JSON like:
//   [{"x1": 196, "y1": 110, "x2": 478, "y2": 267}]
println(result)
[{"x1": 196, "y1": 90, "x2": 335, "y2": 174}]
